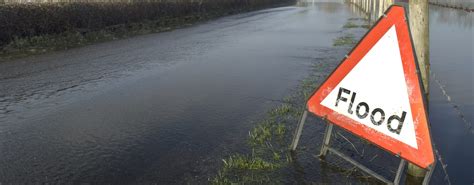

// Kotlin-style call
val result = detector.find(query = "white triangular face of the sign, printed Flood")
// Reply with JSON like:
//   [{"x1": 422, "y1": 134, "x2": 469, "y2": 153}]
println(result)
[{"x1": 321, "y1": 25, "x2": 418, "y2": 149}]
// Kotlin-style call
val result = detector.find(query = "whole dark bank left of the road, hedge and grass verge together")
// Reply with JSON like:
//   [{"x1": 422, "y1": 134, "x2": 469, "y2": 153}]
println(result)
[{"x1": 0, "y1": 0, "x2": 293, "y2": 60}]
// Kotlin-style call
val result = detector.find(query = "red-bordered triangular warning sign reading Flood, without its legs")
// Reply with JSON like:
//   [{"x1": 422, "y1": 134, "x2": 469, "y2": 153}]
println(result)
[{"x1": 307, "y1": 6, "x2": 434, "y2": 168}]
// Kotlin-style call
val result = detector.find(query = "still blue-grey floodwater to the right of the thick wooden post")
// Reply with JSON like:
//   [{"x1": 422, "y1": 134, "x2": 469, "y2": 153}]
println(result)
[{"x1": 430, "y1": 6, "x2": 474, "y2": 184}]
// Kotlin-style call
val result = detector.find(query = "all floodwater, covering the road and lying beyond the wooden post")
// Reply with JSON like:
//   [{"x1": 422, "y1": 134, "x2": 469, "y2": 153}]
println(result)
[{"x1": 0, "y1": 1, "x2": 474, "y2": 184}]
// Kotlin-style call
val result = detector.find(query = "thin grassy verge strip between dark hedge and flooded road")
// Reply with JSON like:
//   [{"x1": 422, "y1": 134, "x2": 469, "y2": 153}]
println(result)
[{"x1": 0, "y1": 0, "x2": 294, "y2": 62}]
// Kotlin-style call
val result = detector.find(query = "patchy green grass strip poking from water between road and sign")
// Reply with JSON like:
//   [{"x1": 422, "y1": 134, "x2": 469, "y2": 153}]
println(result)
[{"x1": 209, "y1": 18, "x2": 368, "y2": 185}]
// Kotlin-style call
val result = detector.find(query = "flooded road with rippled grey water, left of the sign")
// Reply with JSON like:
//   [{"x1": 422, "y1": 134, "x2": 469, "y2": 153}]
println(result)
[{"x1": 0, "y1": 3, "x2": 351, "y2": 184}]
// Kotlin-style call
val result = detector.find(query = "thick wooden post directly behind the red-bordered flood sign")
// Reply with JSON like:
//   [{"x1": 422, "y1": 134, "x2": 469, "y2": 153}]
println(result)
[{"x1": 407, "y1": 0, "x2": 430, "y2": 184}]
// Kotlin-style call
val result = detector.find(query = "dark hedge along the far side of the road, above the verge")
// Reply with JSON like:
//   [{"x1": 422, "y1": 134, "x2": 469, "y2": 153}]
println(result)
[{"x1": 0, "y1": 0, "x2": 293, "y2": 46}]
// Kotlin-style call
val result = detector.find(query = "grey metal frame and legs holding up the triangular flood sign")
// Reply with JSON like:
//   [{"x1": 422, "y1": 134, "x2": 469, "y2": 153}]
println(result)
[{"x1": 290, "y1": 5, "x2": 436, "y2": 185}]
